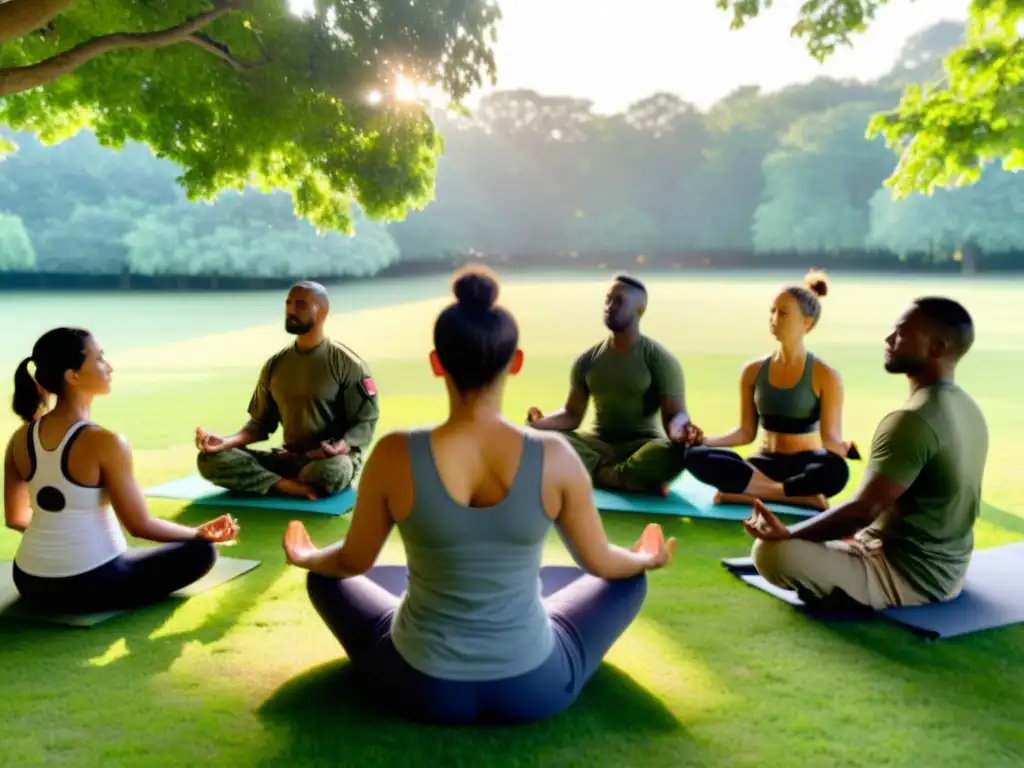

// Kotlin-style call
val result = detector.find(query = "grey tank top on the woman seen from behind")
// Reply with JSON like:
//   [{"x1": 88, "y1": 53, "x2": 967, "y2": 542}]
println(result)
[{"x1": 391, "y1": 430, "x2": 554, "y2": 681}]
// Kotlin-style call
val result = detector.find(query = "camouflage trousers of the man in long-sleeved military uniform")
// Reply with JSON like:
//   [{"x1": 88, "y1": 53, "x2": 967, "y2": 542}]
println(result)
[{"x1": 196, "y1": 449, "x2": 358, "y2": 496}]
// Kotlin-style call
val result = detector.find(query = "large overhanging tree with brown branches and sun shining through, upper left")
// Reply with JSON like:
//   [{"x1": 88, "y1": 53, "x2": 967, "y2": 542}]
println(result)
[{"x1": 0, "y1": 0, "x2": 499, "y2": 232}]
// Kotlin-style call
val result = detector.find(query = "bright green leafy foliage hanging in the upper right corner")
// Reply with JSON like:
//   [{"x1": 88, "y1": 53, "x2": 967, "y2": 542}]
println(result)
[{"x1": 716, "y1": 0, "x2": 1024, "y2": 198}]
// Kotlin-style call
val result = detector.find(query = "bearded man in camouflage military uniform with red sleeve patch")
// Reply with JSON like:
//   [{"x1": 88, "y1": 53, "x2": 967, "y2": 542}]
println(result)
[{"x1": 196, "y1": 281, "x2": 379, "y2": 499}]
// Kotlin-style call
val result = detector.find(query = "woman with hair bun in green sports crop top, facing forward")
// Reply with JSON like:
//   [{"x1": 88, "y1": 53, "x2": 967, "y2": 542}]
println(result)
[{"x1": 686, "y1": 270, "x2": 858, "y2": 510}]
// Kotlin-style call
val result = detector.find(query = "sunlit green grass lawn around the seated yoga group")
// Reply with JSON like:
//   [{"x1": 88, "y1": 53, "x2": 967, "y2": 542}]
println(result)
[{"x1": 0, "y1": 275, "x2": 1024, "y2": 768}]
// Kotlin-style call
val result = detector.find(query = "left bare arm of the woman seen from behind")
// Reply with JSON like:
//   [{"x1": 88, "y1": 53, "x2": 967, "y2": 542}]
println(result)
[{"x1": 304, "y1": 433, "x2": 397, "y2": 579}]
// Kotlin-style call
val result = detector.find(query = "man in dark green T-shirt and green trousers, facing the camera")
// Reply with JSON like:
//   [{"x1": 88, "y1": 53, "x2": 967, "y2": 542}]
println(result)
[{"x1": 526, "y1": 274, "x2": 702, "y2": 494}]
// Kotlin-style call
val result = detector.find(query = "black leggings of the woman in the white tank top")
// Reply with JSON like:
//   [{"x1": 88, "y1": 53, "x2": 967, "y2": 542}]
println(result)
[{"x1": 14, "y1": 540, "x2": 217, "y2": 613}]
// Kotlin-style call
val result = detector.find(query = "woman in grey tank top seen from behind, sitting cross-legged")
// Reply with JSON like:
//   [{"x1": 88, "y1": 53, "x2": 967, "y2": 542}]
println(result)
[{"x1": 284, "y1": 269, "x2": 675, "y2": 724}]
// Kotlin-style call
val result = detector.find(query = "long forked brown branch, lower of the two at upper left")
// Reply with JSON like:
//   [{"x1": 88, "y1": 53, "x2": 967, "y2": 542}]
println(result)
[{"x1": 0, "y1": 0, "x2": 256, "y2": 96}]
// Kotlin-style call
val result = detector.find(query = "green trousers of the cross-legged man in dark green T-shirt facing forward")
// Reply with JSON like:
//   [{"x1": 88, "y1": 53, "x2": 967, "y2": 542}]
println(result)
[{"x1": 562, "y1": 432, "x2": 686, "y2": 494}]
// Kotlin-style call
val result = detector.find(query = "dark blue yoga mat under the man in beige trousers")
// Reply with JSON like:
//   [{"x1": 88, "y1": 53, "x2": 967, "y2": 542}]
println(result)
[{"x1": 722, "y1": 542, "x2": 1024, "y2": 640}]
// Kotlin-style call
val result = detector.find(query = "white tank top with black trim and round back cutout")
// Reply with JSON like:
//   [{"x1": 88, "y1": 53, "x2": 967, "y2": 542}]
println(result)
[{"x1": 14, "y1": 421, "x2": 128, "y2": 579}]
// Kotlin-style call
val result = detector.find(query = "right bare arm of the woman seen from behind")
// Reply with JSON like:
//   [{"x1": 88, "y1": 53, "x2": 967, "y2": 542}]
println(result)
[{"x1": 545, "y1": 435, "x2": 652, "y2": 579}]
